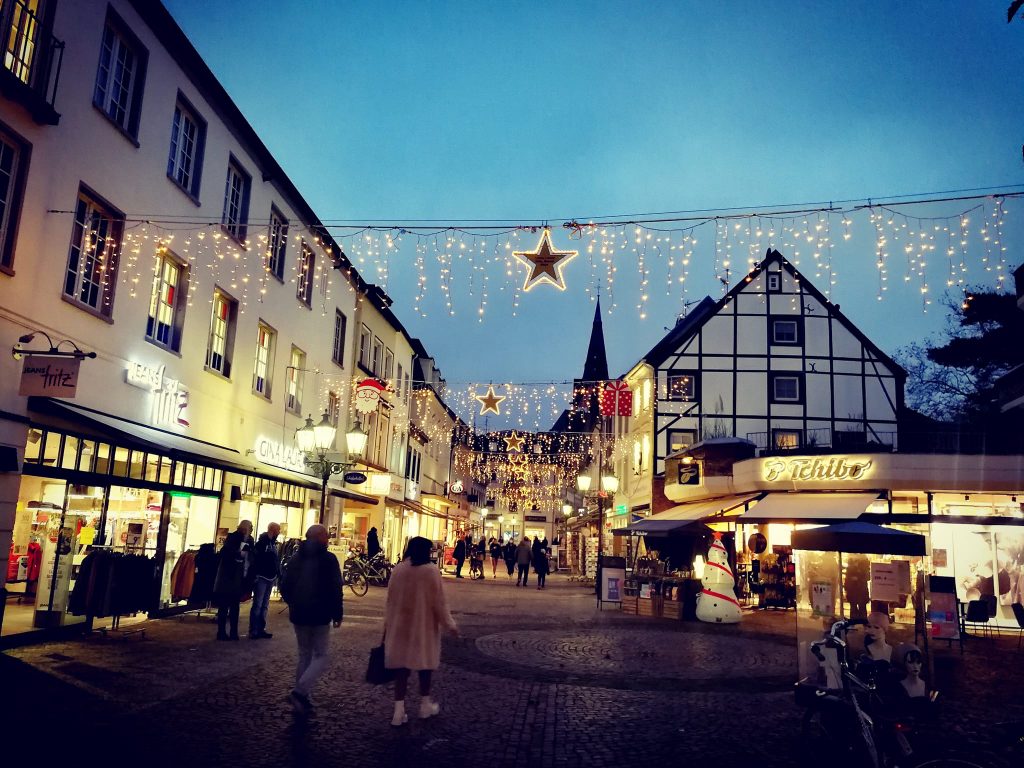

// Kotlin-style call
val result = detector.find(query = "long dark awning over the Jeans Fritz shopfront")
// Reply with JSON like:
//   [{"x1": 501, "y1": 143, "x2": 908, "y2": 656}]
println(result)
[{"x1": 29, "y1": 397, "x2": 319, "y2": 488}]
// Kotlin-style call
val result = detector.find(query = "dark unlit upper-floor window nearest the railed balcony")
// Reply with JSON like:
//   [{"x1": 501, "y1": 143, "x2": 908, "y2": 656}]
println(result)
[{"x1": 92, "y1": 8, "x2": 148, "y2": 139}]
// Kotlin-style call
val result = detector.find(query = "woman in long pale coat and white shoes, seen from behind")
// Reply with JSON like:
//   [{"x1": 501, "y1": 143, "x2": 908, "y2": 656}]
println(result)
[{"x1": 384, "y1": 536, "x2": 459, "y2": 726}]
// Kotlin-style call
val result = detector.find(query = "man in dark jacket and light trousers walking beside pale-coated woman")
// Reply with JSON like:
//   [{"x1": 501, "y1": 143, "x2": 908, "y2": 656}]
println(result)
[{"x1": 281, "y1": 525, "x2": 344, "y2": 715}]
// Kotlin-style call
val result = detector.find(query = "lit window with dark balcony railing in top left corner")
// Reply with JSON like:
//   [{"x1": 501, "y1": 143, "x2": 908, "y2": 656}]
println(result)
[{"x1": 0, "y1": 0, "x2": 65, "y2": 125}]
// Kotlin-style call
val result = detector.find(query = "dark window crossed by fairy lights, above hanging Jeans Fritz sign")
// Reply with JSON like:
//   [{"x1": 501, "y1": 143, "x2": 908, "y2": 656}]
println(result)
[{"x1": 63, "y1": 189, "x2": 124, "y2": 317}]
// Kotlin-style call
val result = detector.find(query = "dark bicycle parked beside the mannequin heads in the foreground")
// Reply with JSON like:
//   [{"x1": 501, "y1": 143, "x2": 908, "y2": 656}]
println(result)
[{"x1": 796, "y1": 618, "x2": 982, "y2": 768}]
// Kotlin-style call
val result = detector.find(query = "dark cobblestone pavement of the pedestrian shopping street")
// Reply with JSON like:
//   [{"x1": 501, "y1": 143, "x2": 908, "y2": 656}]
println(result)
[{"x1": 0, "y1": 577, "x2": 1024, "y2": 768}]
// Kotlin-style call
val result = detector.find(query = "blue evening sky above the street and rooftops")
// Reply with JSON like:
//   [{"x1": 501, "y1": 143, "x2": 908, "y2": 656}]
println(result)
[{"x1": 165, "y1": 0, "x2": 1024, "y2": 421}]
